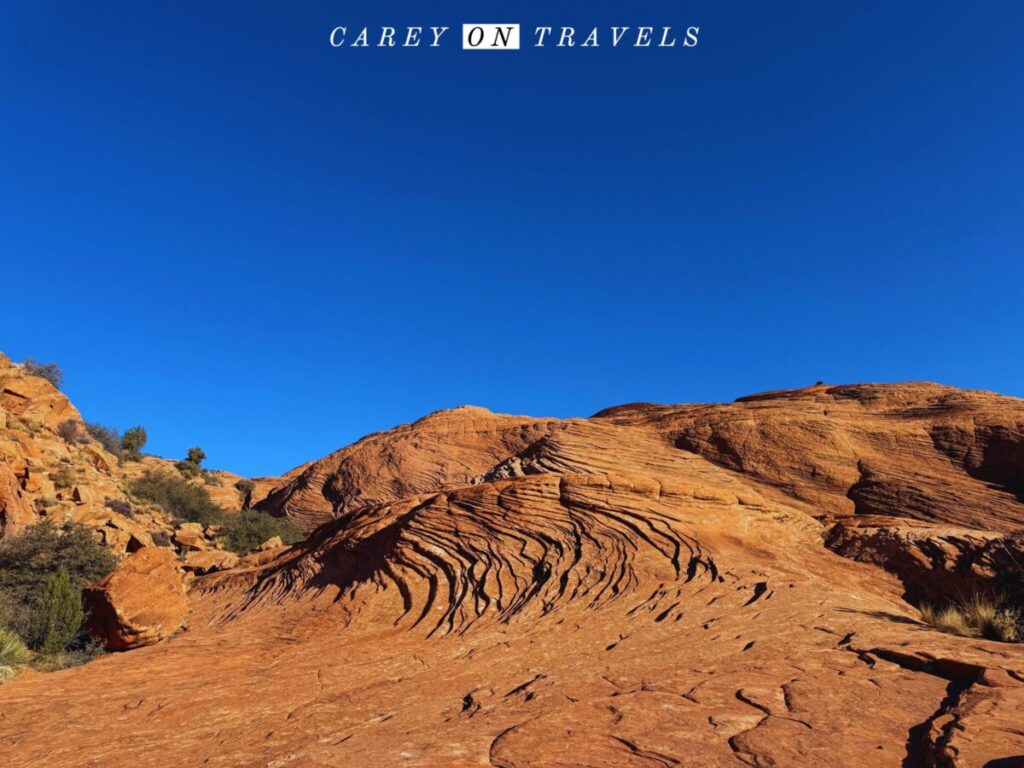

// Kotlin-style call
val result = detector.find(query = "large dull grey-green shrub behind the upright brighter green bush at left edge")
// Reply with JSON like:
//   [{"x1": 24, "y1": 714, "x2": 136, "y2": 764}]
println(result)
[{"x1": 0, "y1": 522, "x2": 118, "y2": 640}]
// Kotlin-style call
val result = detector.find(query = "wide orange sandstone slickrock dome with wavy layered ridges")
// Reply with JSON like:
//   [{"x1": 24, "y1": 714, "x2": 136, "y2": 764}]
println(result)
[{"x1": 0, "y1": 385, "x2": 1024, "y2": 768}]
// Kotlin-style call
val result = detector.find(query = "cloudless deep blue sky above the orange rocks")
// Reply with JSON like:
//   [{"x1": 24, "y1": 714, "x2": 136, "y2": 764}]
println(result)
[{"x1": 0, "y1": 0, "x2": 1024, "y2": 474}]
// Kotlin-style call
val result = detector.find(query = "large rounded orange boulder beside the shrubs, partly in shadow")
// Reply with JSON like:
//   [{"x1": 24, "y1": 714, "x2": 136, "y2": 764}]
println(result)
[{"x1": 83, "y1": 547, "x2": 188, "y2": 650}]
